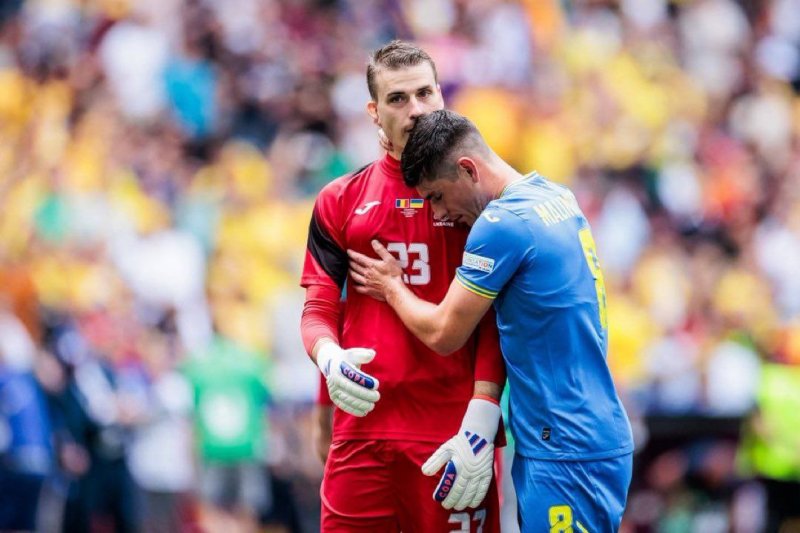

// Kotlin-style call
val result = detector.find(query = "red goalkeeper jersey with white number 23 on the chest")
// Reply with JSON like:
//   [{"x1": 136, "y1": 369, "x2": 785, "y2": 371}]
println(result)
[{"x1": 301, "y1": 155, "x2": 505, "y2": 442}]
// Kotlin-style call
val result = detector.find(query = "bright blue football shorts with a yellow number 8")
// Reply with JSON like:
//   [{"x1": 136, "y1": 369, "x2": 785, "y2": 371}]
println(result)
[{"x1": 511, "y1": 454, "x2": 633, "y2": 533}]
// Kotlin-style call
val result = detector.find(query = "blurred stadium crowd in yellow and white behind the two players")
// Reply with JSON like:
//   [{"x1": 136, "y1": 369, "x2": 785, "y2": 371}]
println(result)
[{"x1": 0, "y1": 0, "x2": 800, "y2": 533}]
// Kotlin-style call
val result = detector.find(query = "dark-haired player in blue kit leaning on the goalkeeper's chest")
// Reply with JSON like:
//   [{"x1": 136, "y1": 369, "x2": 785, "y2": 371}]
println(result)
[{"x1": 350, "y1": 111, "x2": 633, "y2": 533}]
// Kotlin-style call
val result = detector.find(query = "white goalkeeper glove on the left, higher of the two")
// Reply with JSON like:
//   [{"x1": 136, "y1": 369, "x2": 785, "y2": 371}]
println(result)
[{"x1": 317, "y1": 342, "x2": 381, "y2": 416}]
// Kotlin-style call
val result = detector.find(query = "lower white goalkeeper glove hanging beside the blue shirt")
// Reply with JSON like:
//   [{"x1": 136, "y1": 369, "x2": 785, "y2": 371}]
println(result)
[{"x1": 422, "y1": 398, "x2": 500, "y2": 511}]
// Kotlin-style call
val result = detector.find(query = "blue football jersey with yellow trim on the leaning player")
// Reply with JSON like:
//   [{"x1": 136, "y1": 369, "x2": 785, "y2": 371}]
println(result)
[{"x1": 456, "y1": 173, "x2": 633, "y2": 460}]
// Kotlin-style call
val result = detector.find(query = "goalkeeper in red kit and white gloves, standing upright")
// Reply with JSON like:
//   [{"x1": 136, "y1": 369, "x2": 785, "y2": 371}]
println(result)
[{"x1": 301, "y1": 41, "x2": 505, "y2": 533}]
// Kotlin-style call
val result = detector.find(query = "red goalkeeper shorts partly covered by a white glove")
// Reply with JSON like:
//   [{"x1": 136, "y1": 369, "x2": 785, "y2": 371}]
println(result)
[{"x1": 320, "y1": 440, "x2": 500, "y2": 533}]
